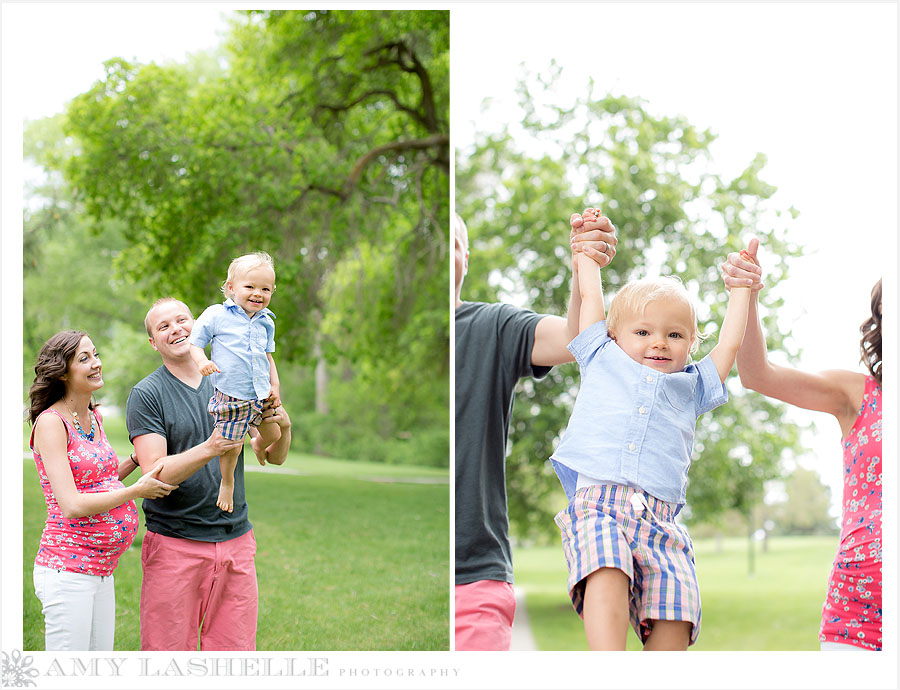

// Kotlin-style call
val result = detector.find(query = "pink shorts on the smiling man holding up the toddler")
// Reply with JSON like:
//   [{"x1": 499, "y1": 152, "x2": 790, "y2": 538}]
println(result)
[{"x1": 141, "y1": 530, "x2": 259, "y2": 651}]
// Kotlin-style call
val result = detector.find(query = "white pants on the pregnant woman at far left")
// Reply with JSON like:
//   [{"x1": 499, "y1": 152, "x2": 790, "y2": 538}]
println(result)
[{"x1": 34, "y1": 565, "x2": 116, "y2": 652}]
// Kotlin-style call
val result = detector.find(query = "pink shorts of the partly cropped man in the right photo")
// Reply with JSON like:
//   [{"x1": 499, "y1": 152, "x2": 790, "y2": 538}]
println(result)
[{"x1": 454, "y1": 580, "x2": 516, "y2": 652}]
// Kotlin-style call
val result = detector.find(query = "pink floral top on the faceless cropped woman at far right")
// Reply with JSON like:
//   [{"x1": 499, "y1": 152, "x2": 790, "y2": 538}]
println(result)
[{"x1": 819, "y1": 376, "x2": 881, "y2": 649}]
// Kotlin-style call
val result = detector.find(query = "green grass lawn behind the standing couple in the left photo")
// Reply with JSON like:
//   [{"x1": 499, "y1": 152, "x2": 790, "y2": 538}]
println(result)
[{"x1": 22, "y1": 416, "x2": 450, "y2": 650}]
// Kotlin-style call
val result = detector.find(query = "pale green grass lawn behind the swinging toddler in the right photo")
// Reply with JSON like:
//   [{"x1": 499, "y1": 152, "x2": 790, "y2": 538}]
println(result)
[{"x1": 514, "y1": 537, "x2": 838, "y2": 651}]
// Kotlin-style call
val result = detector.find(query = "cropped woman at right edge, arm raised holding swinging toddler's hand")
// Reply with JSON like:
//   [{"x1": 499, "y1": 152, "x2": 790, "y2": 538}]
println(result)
[{"x1": 722, "y1": 245, "x2": 882, "y2": 651}]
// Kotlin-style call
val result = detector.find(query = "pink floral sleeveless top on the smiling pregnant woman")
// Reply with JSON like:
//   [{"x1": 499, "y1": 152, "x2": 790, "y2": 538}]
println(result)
[{"x1": 31, "y1": 409, "x2": 138, "y2": 575}]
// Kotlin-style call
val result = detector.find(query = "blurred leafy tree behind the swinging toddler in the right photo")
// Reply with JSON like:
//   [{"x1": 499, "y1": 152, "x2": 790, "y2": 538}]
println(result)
[{"x1": 456, "y1": 64, "x2": 799, "y2": 537}]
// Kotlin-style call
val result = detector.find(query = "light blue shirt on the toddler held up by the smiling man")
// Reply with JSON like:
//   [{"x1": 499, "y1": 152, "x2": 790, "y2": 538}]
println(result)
[{"x1": 190, "y1": 297, "x2": 275, "y2": 400}]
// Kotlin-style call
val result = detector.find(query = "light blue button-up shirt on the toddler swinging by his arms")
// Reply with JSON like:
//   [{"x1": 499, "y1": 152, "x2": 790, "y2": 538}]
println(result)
[{"x1": 551, "y1": 321, "x2": 728, "y2": 505}]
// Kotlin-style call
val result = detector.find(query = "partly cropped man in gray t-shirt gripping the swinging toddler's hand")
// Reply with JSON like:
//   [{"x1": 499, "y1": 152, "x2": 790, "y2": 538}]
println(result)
[{"x1": 454, "y1": 213, "x2": 616, "y2": 651}]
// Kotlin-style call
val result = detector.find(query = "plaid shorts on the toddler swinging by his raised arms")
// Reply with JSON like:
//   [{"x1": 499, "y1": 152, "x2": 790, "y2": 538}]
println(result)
[{"x1": 556, "y1": 484, "x2": 700, "y2": 644}]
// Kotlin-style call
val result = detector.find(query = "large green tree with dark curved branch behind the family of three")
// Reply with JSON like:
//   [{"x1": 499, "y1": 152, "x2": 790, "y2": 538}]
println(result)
[{"x1": 26, "y1": 11, "x2": 449, "y2": 465}]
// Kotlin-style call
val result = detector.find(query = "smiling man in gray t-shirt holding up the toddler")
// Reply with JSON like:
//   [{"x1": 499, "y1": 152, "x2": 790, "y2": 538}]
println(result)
[{"x1": 125, "y1": 298, "x2": 291, "y2": 651}]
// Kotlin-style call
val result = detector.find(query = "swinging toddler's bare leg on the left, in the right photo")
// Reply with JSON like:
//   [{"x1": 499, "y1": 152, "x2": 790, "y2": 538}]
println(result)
[{"x1": 583, "y1": 568, "x2": 631, "y2": 651}]
